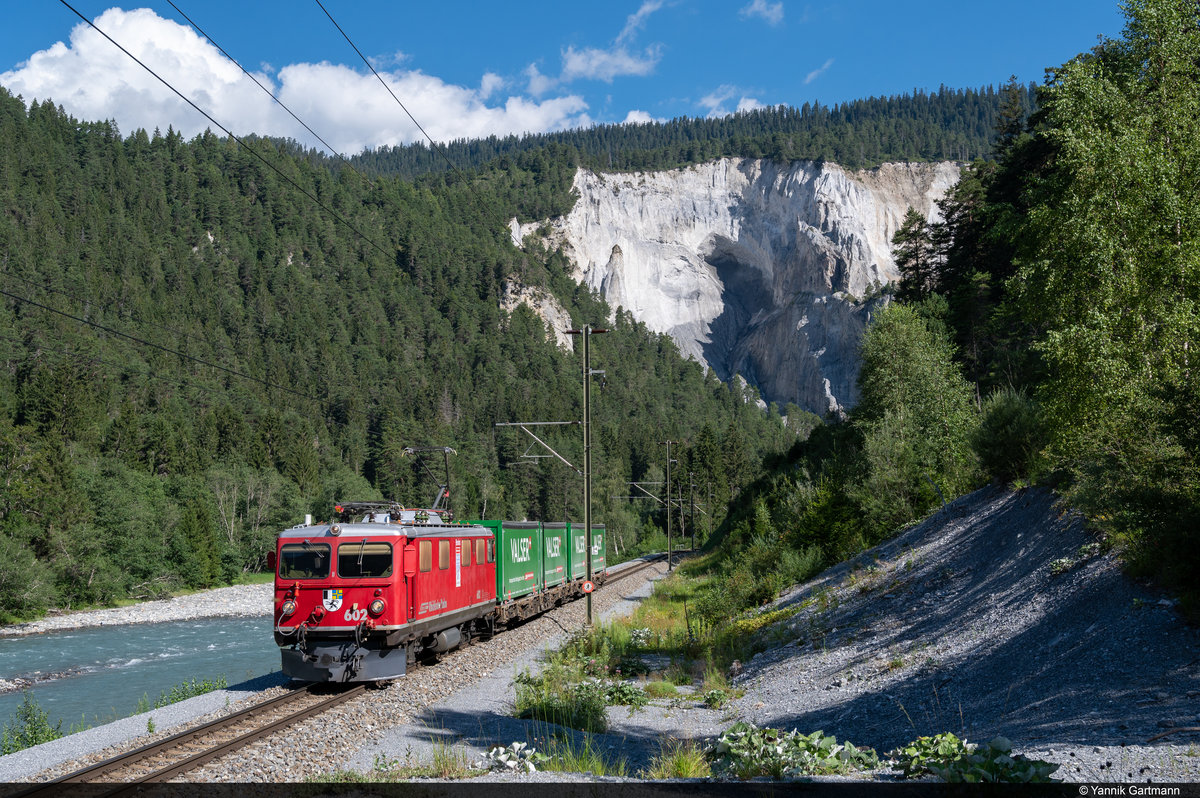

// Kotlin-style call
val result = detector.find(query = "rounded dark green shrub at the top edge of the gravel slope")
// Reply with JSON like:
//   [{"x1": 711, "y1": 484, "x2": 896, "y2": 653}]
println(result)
[{"x1": 971, "y1": 389, "x2": 1048, "y2": 482}]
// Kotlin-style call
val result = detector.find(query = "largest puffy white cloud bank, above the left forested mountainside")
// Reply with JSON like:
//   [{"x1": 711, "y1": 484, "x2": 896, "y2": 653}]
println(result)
[{"x1": 0, "y1": 8, "x2": 592, "y2": 154}]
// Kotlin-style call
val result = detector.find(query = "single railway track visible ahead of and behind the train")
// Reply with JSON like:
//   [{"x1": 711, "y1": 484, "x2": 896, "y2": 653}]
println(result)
[{"x1": 28, "y1": 554, "x2": 666, "y2": 782}]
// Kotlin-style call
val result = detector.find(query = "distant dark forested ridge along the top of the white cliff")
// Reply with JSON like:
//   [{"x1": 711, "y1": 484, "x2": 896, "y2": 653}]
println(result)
[{"x1": 353, "y1": 84, "x2": 1036, "y2": 176}]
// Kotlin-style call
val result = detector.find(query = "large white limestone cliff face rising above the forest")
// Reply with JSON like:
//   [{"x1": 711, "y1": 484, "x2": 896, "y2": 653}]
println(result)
[{"x1": 511, "y1": 158, "x2": 959, "y2": 415}]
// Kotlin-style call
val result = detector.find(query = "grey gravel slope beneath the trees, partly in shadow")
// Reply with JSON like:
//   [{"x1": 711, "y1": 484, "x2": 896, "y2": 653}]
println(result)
[{"x1": 736, "y1": 488, "x2": 1200, "y2": 781}]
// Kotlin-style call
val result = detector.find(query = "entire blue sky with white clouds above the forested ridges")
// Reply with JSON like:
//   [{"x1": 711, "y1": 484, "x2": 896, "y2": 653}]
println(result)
[{"x1": 0, "y1": 0, "x2": 1122, "y2": 152}]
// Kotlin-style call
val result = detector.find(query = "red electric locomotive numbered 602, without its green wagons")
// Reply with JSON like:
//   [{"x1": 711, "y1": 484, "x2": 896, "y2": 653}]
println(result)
[{"x1": 275, "y1": 502, "x2": 496, "y2": 682}]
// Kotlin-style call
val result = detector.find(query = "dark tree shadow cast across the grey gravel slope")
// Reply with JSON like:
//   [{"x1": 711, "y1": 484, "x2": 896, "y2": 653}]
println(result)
[{"x1": 748, "y1": 488, "x2": 1200, "y2": 750}]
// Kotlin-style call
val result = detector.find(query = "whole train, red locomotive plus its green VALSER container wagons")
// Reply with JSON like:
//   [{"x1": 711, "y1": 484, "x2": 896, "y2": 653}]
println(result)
[{"x1": 275, "y1": 502, "x2": 607, "y2": 682}]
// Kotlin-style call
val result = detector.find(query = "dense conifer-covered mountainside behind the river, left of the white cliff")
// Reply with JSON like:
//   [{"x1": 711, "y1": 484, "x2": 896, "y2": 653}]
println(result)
[{"x1": 0, "y1": 90, "x2": 792, "y2": 614}]
